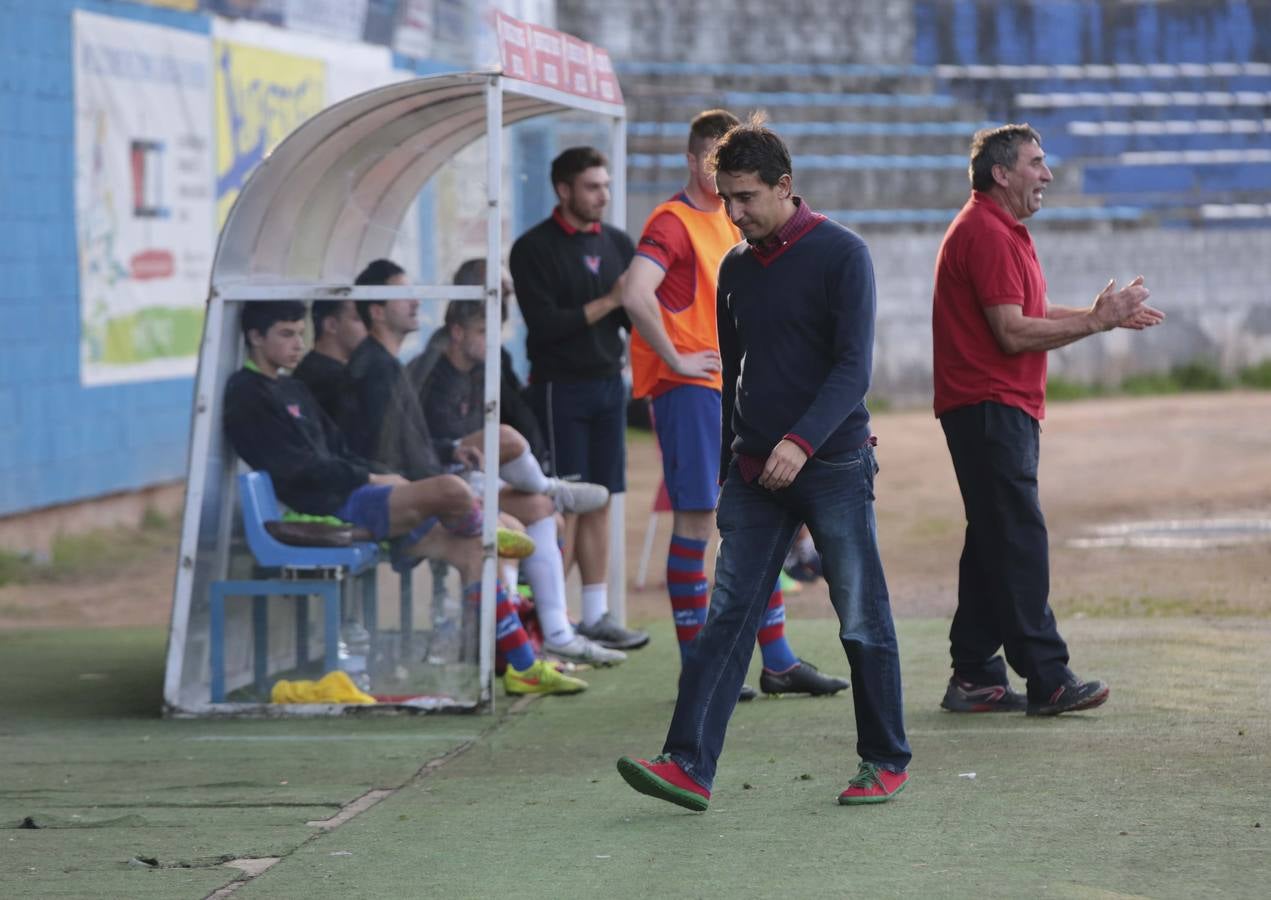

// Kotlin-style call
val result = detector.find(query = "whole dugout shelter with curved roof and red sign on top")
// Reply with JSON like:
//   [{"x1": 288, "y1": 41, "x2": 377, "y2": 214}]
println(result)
[{"x1": 164, "y1": 17, "x2": 625, "y2": 716}]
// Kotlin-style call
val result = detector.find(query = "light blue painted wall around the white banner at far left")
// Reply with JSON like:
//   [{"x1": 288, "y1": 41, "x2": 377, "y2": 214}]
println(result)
[{"x1": 0, "y1": 0, "x2": 211, "y2": 516}]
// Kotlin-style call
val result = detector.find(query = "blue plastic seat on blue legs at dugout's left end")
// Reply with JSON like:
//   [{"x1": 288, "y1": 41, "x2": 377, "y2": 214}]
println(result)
[{"x1": 208, "y1": 472, "x2": 380, "y2": 703}]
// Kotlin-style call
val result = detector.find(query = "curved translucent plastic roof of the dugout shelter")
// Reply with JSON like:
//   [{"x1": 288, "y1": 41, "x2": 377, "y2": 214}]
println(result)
[{"x1": 212, "y1": 72, "x2": 625, "y2": 294}]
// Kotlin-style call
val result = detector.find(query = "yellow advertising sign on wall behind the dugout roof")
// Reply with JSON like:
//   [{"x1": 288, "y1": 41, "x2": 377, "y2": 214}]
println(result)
[{"x1": 214, "y1": 41, "x2": 327, "y2": 228}]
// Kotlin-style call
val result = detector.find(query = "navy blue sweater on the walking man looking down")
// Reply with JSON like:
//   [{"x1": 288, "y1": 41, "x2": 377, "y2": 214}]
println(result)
[{"x1": 717, "y1": 220, "x2": 876, "y2": 481}]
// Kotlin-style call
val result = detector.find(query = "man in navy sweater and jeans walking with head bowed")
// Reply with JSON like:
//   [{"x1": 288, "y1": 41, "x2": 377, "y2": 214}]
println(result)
[{"x1": 618, "y1": 118, "x2": 910, "y2": 811}]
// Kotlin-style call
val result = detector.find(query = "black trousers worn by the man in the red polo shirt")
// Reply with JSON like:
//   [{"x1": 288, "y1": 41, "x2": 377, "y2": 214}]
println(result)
[{"x1": 941, "y1": 402, "x2": 1070, "y2": 702}]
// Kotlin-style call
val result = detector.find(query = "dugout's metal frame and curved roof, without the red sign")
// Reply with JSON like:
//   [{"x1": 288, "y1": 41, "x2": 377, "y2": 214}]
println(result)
[{"x1": 164, "y1": 71, "x2": 627, "y2": 716}]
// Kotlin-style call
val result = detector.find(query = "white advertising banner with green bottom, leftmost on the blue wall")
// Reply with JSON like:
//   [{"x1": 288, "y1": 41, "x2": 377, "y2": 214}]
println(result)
[{"x1": 74, "y1": 10, "x2": 215, "y2": 385}]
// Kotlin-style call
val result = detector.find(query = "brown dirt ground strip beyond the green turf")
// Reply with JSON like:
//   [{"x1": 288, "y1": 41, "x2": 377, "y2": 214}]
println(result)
[{"x1": 0, "y1": 393, "x2": 1271, "y2": 629}]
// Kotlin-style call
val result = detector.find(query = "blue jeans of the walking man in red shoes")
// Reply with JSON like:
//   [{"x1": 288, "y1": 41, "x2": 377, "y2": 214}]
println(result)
[{"x1": 662, "y1": 446, "x2": 910, "y2": 789}]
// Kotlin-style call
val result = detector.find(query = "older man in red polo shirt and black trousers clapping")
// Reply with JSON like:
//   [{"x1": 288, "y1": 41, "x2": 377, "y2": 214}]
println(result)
[{"x1": 932, "y1": 125, "x2": 1164, "y2": 716}]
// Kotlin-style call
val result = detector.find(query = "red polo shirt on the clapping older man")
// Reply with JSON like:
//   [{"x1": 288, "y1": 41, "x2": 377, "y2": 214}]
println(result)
[{"x1": 932, "y1": 191, "x2": 1046, "y2": 419}]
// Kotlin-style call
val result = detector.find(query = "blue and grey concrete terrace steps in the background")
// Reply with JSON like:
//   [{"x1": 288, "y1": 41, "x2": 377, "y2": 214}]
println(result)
[{"x1": 618, "y1": 62, "x2": 1271, "y2": 230}]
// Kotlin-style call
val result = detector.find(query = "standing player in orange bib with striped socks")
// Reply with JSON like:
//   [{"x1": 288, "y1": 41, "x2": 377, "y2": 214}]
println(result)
[{"x1": 623, "y1": 109, "x2": 848, "y2": 700}]
